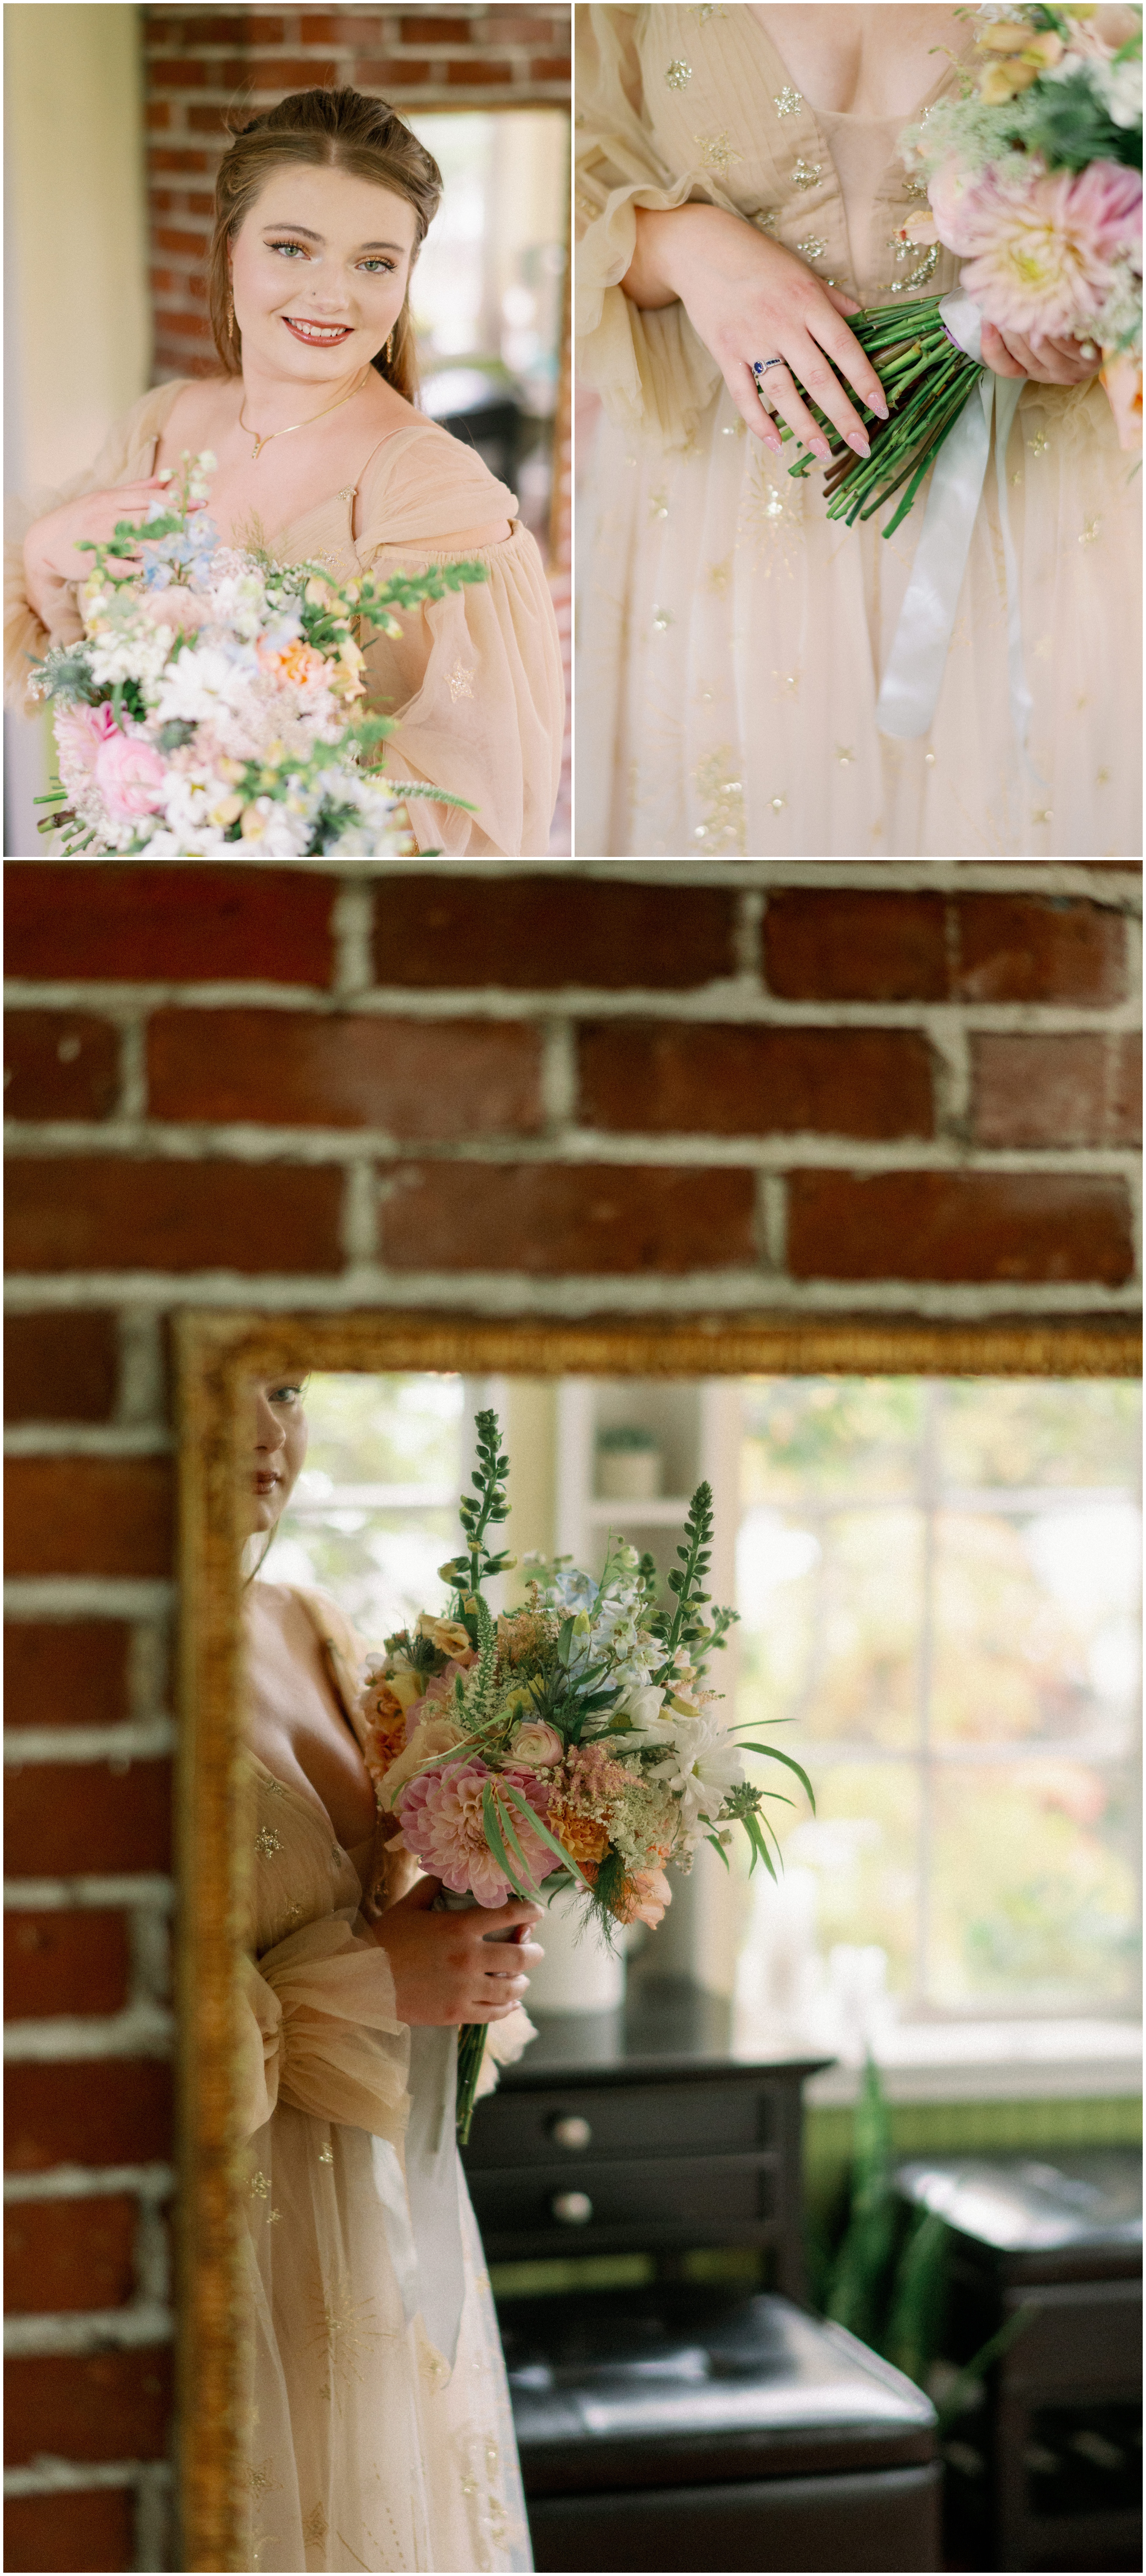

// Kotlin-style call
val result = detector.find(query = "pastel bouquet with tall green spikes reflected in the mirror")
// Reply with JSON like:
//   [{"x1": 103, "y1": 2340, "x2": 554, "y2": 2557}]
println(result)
[{"x1": 353, "y1": 1412, "x2": 811, "y2": 2143}]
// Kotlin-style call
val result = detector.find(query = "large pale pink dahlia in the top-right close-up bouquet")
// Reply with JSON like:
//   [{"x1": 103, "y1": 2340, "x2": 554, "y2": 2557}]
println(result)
[{"x1": 958, "y1": 162, "x2": 1141, "y2": 338}]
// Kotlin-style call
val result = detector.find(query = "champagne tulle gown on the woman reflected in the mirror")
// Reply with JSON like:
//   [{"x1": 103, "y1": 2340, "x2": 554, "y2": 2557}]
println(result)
[{"x1": 242, "y1": 1595, "x2": 530, "y2": 2571}]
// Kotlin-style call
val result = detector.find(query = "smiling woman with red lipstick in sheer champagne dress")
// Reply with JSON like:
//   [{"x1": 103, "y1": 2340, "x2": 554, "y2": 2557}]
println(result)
[{"x1": 5, "y1": 90, "x2": 562, "y2": 858}]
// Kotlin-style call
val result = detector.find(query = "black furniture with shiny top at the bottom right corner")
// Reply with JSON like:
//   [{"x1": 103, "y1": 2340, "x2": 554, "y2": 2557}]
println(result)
[{"x1": 899, "y1": 2151, "x2": 1141, "y2": 2571}]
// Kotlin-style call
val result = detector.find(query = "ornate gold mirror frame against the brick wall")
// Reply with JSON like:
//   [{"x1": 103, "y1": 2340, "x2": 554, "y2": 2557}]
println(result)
[{"x1": 175, "y1": 1311, "x2": 1141, "y2": 2571}]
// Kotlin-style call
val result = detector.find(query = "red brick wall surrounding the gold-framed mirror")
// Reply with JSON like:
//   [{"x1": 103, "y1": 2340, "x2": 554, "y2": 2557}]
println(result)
[{"x1": 8, "y1": 861, "x2": 1138, "y2": 2568}]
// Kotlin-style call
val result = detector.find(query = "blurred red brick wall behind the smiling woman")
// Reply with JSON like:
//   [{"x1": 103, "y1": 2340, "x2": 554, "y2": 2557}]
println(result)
[{"x1": 142, "y1": 0, "x2": 572, "y2": 855}]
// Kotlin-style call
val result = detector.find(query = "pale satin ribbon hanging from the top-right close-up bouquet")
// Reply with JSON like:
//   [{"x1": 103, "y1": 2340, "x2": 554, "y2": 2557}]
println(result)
[{"x1": 876, "y1": 288, "x2": 1038, "y2": 778}]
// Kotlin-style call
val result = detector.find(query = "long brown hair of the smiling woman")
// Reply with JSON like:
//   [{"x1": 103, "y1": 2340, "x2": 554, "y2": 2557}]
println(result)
[{"x1": 206, "y1": 90, "x2": 443, "y2": 402}]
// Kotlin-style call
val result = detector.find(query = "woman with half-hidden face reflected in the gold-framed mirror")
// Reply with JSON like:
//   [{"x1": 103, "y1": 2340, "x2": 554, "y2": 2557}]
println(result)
[{"x1": 233, "y1": 1376, "x2": 541, "y2": 2571}]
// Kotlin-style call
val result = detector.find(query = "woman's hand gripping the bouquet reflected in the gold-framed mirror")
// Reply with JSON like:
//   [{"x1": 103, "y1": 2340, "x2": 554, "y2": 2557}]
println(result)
[{"x1": 371, "y1": 1878, "x2": 544, "y2": 2027}]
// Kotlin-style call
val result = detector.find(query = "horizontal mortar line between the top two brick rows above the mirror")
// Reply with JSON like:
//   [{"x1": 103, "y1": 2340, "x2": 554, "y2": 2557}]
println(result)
[{"x1": 5, "y1": 976, "x2": 1141, "y2": 1043}]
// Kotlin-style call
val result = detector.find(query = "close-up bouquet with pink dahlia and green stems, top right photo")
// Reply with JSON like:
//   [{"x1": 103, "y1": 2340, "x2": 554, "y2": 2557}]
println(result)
[{"x1": 780, "y1": 0, "x2": 1141, "y2": 536}]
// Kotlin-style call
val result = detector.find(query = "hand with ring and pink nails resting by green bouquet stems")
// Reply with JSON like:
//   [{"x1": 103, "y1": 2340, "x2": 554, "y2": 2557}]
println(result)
[{"x1": 621, "y1": 206, "x2": 888, "y2": 458}]
